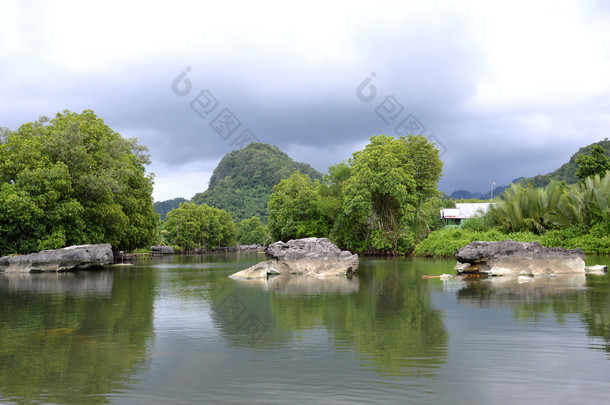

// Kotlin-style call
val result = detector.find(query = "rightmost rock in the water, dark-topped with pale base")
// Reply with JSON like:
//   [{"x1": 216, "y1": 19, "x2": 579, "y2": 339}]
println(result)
[{"x1": 455, "y1": 240, "x2": 585, "y2": 276}]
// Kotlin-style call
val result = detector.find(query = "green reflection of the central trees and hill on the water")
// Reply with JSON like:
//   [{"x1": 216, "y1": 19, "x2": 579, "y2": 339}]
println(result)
[{"x1": 210, "y1": 260, "x2": 448, "y2": 377}]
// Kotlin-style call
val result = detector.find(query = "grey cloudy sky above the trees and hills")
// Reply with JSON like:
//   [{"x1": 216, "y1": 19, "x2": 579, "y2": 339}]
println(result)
[{"x1": 0, "y1": 0, "x2": 610, "y2": 200}]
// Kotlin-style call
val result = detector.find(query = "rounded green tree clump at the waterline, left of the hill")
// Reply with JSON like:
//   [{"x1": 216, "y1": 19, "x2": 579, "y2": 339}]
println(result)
[{"x1": 163, "y1": 203, "x2": 237, "y2": 250}]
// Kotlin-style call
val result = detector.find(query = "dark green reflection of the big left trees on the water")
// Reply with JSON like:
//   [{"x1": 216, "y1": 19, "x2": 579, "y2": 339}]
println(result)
[{"x1": 0, "y1": 269, "x2": 156, "y2": 403}]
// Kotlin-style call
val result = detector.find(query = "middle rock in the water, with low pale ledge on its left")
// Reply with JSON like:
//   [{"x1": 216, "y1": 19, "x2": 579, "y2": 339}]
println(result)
[{"x1": 231, "y1": 238, "x2": 358, "y2": 279}]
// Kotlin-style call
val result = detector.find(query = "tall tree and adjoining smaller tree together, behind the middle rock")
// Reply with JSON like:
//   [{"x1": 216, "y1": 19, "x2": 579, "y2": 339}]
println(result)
[{"x1": 269, "y1": 135, "x2": 442, "y2": 253}]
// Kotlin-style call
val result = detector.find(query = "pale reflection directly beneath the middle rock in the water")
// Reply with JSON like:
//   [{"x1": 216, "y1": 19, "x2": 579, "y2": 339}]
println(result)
[{"x1": 232, "y1": 275, "x2": 360, "y2": 295}]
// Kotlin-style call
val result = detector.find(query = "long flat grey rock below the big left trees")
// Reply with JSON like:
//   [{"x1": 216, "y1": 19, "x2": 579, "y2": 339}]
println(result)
[{"x1": 0, "y1": 244, "x2": 113, "y2": 273}]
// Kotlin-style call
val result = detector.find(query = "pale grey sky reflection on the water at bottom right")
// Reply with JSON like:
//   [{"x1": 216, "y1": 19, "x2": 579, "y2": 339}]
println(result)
[{"x1": 432, "y1": 292, "x2": 610, "y2": 404}]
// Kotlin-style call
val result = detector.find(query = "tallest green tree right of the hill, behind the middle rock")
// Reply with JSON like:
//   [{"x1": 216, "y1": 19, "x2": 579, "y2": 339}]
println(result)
[{"x1": 333, "y1": 135, "x2": 443, "y2": 251}]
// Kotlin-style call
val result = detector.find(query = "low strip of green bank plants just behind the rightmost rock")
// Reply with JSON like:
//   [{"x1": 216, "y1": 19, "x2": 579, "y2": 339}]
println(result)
[{"x1": 413, "y1": 228, "x2": 610, "y2": 258}]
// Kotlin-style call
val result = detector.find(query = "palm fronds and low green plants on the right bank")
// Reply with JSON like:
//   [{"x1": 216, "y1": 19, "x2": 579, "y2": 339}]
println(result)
[{"x1": 414, "y1": 171, "x2": 610, "y2": 257}]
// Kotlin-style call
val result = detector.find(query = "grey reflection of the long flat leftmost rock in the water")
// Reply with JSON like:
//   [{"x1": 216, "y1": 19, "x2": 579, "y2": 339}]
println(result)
[{"x1": 0, "y1": 271, "x2": 114, "y2": 297}]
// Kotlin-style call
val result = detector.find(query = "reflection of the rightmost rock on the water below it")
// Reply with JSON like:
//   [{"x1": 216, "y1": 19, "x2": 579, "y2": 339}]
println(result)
[{"x1": 456, "y1": 274, "x2": 587, "y2": 308}]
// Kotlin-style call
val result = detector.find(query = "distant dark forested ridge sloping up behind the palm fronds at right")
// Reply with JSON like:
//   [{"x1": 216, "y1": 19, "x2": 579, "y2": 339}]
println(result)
[{"x1": 450, "y1": 138, "x2": 610, "y2": 200}]
